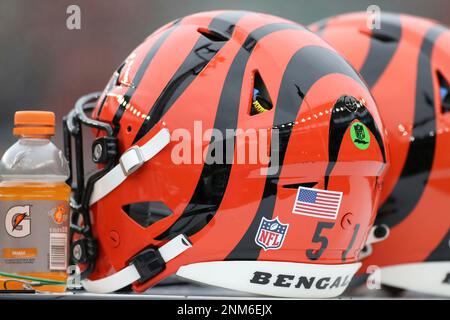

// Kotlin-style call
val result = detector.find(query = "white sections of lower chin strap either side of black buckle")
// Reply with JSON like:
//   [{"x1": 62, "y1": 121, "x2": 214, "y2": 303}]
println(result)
[{"x1": 81, "y1": 235, "x2": 192, "y2": 294}]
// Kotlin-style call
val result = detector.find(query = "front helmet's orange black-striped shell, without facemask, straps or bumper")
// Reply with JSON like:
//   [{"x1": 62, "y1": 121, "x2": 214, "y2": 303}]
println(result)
[{"x1": 75, "y1": 11, "x2": 389, "y2": 291}]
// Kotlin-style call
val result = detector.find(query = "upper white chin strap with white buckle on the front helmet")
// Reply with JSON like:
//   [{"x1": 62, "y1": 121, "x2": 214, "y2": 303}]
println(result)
[{"x1": 89, "y1": 128, "x2": 170, "y2": 205}]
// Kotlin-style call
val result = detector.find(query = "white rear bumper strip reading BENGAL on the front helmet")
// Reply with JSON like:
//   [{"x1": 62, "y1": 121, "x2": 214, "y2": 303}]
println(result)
[{"x1": 177, "y1": 261, "x2": 361, "y2": 299}]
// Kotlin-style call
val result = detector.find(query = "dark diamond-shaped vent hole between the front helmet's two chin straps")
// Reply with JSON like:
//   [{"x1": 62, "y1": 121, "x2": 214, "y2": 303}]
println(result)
[{"x1": 122, "y1": 201, "x2": 173, "y2": 228}]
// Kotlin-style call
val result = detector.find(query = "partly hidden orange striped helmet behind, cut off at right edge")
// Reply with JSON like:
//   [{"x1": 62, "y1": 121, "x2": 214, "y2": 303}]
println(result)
[{"x1": 311, "y1": 13, "x2": 450, "y2": 296}]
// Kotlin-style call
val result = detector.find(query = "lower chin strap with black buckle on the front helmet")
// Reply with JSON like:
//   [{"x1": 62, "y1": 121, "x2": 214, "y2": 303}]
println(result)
[{"x1": 81, "y1": 235, "x2": 192, "y2": 293}]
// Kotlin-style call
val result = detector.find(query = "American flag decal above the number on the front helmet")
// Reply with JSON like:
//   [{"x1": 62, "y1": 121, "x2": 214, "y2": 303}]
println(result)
[{"x1": 292, "y1": 187, "x2": 342, "y2": 220}]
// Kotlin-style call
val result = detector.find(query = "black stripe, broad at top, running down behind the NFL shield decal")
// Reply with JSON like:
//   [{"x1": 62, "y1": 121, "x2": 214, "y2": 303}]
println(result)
[{"x1": 226, "y1": 46, "x2": 365, "y2": 260}]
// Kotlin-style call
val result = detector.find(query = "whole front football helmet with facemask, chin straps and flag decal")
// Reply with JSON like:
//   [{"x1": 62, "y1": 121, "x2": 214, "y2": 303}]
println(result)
[{"x1": 65, "y1": 11, "x2": 389, "y2": 297}]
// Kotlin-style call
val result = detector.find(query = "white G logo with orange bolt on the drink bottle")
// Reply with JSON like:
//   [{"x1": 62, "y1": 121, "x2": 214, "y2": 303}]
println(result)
[{"x1": 5, "y1": 205, "x2": 31, "y2": 238}]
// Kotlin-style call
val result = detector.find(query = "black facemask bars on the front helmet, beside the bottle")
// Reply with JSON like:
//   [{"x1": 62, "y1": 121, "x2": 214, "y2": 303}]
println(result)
[{"x1": 63, "y1": 92, "x2": 118, "y2": 278}]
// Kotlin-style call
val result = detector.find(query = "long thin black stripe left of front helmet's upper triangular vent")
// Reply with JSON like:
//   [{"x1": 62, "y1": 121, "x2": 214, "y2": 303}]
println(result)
[{"x1": 157, "y1": 23, "x2": 304, "y2": 240}]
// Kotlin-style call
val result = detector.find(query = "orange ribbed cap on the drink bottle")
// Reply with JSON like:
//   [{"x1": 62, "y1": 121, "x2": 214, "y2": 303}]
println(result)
[{"x1": 13, "y1": 111, "x2": 55, "y2": 136}]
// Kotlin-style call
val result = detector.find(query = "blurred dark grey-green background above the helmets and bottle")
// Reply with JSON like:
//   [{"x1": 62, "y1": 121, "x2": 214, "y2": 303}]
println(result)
[{"x1": 0, "y1": 0, "x2": 450, "y2": 154}]
